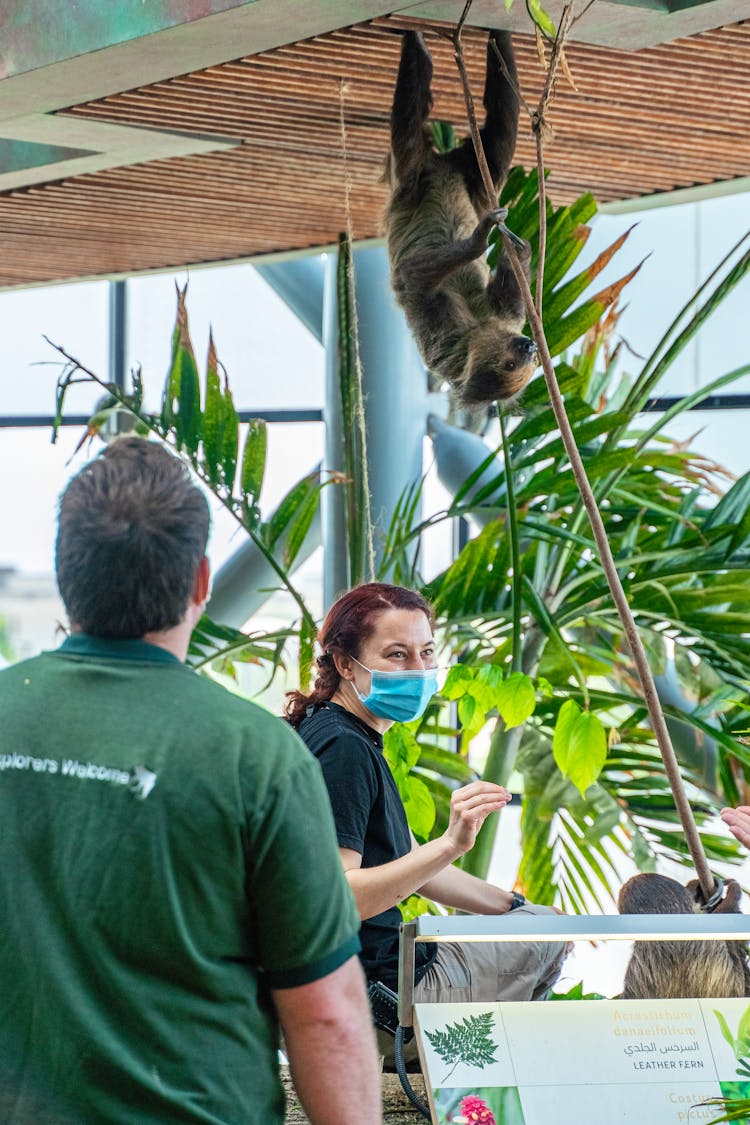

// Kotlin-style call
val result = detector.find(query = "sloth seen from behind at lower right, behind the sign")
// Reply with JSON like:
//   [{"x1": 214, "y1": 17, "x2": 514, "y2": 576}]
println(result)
[{"x1": 617, "y1": 874, "x2": 750, "y2": 1000}]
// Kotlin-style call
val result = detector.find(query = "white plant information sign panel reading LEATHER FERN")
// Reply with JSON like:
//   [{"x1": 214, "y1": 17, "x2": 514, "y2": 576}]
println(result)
[{"x1": 415, "y1": 999, "x2": 750, "y2": 1125}]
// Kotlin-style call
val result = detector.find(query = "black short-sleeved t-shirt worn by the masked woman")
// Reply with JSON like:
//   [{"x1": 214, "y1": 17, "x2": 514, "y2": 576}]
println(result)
[{"x1": 297, "y1": 703, "x2": 437, "y2": 990}]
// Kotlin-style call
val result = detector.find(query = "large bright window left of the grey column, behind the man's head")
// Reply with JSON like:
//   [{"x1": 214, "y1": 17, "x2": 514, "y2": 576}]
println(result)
[{"x1": 0, "y1": 259, "x2": 324, "y2": 657}]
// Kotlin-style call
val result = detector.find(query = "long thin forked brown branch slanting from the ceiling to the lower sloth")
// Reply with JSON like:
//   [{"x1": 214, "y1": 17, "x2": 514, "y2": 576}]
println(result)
[{"x1": 452, "y1": 0, "x2": 721, "y2": 903}]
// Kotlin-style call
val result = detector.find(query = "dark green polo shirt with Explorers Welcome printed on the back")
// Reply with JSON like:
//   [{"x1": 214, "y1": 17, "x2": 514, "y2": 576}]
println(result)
[{"x1": 0, "y1": 635, "x2": 359, "y2": 1125}]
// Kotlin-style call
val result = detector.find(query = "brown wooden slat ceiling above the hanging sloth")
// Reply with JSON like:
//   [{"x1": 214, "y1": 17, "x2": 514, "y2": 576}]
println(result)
[{"x1": 0, "y1": 19, "x2": 750, "y2": 286}]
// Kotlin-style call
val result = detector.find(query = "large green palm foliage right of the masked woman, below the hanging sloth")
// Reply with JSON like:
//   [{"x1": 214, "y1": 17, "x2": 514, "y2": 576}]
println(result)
[{"x1": 389, "y1": 169, "x2": 750, "y2": 910}]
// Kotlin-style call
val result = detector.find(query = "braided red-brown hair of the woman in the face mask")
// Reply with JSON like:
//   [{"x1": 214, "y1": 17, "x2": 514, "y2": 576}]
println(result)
[{"x1": 284, "y1": 582, "x2": 433, "y2": 727}]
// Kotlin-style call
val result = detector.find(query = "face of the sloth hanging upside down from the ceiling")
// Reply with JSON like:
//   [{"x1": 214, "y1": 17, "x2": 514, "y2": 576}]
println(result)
[{"x1": 461, "y1": 330, "x2": 539, "y2": 406}]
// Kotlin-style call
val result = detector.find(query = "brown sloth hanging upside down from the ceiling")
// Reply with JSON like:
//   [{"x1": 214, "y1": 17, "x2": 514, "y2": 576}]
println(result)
[{"x1": 386, "y1": 32, "x2": 537, "y2": 406}]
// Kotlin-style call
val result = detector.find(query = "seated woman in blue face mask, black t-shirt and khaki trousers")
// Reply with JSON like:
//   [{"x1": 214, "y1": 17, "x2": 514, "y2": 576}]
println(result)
[{"x1": 287, "y1": 583, "x2": 564, "y2": 1050}]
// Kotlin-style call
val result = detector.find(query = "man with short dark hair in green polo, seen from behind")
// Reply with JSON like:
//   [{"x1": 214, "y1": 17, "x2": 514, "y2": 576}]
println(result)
[{"x1": 0, "y1": 438, "x2": 381, "y2": 1125}]
